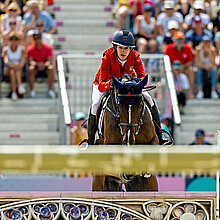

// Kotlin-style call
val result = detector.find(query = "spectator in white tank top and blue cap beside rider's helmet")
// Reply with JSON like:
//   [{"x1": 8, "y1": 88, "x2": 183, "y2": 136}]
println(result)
[{"x1": 134, "y1": 4, "x2": 157, "y2": 54}]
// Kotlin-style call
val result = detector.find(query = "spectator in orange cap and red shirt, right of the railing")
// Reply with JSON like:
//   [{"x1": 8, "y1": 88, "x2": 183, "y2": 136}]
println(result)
[{"x1": 165, "y1": 31, "x2": 195, "y2": 99}]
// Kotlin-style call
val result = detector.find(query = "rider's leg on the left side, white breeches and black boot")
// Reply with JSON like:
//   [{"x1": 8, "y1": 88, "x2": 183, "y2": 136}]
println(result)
[{"x1": 88, "y1": 84, "x2": 106, "y2": 144}]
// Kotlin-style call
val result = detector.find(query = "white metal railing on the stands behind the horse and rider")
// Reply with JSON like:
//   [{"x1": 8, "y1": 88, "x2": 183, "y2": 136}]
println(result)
[{"x1": 57, "y1": 54, "x2": 181, "y2": 144}]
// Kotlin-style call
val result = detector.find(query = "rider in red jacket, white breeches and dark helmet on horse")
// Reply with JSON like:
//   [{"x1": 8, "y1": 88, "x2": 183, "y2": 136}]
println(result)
[{"x1": 88, "y1": 30, "x2": 167, "y2": 145}]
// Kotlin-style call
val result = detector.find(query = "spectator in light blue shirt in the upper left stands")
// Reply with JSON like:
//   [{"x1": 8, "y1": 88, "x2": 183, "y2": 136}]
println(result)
[{"x1": 24, "y1": 0, "x2": 57, "y2": 34}]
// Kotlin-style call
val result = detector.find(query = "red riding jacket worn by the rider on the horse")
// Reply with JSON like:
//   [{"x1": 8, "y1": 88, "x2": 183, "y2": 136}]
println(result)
[{"x1": 93, "y1": 47, "x2": 145, "y2": 92}]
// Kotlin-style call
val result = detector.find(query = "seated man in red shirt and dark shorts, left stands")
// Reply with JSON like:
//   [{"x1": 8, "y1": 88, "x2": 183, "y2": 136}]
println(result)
[{"x1": 27, "y1": 31, "x2": 56, "y2": 99}]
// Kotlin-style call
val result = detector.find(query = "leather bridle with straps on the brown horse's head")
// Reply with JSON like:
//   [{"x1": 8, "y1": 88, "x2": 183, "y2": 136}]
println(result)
[{"x1": 106, "y1": 89, "x2": 145, "y2": 145}]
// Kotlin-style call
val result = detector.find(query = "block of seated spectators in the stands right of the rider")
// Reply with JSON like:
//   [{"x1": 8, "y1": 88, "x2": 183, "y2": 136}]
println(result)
[{"x1": 114, "y1": 0, "x2": 220, "y2": 108}]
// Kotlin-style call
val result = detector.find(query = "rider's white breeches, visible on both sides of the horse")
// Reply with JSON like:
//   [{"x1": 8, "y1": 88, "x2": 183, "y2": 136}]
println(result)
[{"x1": 91, "y1": 84, "x2": 154, "y2": 115}]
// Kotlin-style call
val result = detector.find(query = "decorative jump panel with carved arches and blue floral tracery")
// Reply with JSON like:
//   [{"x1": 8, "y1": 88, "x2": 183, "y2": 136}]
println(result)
[{"x1": 0, "y1": 194, "x2": 216, "y2": 220}]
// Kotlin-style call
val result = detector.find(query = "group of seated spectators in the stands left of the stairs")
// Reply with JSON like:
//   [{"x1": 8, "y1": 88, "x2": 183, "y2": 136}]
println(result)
[{"x1": 0, "y1": 0, "x2": 57, "y2": 101}]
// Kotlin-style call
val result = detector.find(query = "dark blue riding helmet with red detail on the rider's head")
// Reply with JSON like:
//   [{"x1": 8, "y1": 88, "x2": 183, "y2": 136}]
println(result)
[{"x1": 112, "y1": 30, "x2": 135, "y2": 47}]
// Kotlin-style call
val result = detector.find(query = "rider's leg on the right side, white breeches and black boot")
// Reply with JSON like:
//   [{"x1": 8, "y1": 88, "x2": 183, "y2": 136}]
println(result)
[{"x1": 143, "y1": 91, "x2": 168, "y2": 145}]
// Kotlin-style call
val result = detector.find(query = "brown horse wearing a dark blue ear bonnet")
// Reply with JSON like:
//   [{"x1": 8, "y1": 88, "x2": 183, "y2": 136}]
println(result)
[{"x1": 92, "y1": 75, "x2": 159, "y2": 191}]
